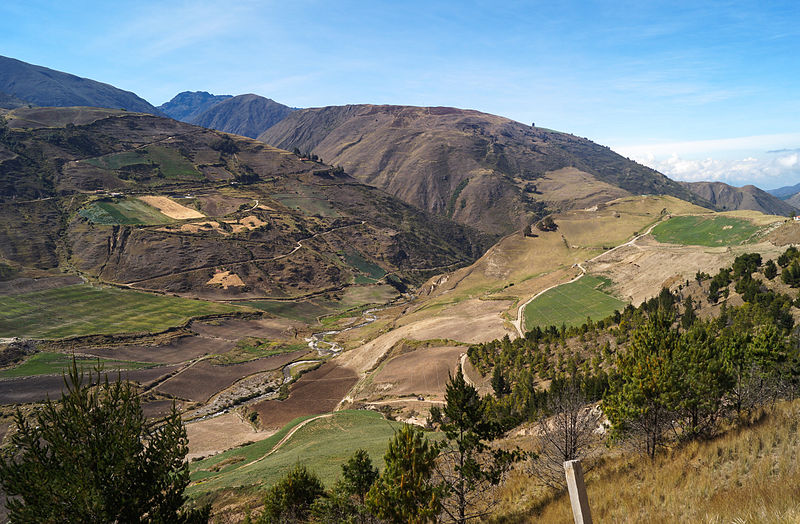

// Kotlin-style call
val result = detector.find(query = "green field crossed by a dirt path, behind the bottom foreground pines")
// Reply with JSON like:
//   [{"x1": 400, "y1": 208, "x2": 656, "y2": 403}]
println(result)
[{"x1": 188, "y1": 411, "x2": 433, "y2": 496}]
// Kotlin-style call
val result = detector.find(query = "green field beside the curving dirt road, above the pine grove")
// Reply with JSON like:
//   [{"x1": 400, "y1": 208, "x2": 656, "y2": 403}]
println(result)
[{"x1": 525, "y1": 275, "x2": 627, "y2": 329}]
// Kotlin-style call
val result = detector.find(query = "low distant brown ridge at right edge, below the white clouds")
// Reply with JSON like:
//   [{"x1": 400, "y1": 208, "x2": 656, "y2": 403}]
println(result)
[{"x1": 681, "y1": 182, "x2": 796, "y2": 216}]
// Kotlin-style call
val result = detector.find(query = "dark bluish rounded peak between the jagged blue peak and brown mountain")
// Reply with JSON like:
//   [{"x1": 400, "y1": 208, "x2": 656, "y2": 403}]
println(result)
[{"x1": 187, "y1": 94, "x2": 293, "y2": 138}]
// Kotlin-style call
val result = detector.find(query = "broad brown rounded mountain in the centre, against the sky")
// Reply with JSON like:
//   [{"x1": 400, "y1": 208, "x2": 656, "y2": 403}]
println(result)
[{"x1": 259, "y1": 105, "x2": 707, "y2": 233}]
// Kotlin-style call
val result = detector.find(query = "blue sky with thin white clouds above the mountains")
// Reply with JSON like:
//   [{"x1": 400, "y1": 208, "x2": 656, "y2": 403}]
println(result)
[{"x1": 0, "y1": 0, "x2": 800, "y2": 188}]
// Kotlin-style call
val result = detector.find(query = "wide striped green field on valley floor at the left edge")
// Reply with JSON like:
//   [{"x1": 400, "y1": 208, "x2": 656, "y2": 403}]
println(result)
[{"x1": 0, "y1": 284, "x2": 240, "y2": 339}]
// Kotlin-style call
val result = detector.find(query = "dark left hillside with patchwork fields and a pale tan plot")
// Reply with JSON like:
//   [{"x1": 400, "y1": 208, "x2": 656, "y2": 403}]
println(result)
[{"x1": 0, "y1": 108, "x2": 491, "y2": 298}]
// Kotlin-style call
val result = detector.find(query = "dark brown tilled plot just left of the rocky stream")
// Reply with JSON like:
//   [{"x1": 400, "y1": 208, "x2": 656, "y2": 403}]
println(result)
[{"x1": 156, "y1": 351, "x2": 305, "y2": 402}]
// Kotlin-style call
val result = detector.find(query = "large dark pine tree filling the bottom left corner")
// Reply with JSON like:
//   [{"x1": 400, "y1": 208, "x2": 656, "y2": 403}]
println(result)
[{"x1": 0, "y1": 361, "x2": 209, "y2": 523}]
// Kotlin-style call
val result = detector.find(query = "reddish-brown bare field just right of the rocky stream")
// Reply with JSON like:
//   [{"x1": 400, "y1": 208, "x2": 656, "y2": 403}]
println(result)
[{"x1": 253, "y1": 362, "x2": 358, "y2": 429}]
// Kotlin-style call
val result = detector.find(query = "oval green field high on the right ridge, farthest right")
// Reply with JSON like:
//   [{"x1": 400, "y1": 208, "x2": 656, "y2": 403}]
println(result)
[{"x1": 653, "y1": 216, "x2": 759, "y2": 247}]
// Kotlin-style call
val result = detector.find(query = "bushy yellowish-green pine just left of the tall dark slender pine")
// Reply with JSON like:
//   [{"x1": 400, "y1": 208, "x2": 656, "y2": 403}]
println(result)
[{"x1": 366, "y1": 424, "x2": 444, "y2": 524}]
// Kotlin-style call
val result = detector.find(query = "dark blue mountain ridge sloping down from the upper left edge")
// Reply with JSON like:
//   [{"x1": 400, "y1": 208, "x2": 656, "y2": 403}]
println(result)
[{"x1": 0, "y1": 56, "x2": 161, "y2": 114}]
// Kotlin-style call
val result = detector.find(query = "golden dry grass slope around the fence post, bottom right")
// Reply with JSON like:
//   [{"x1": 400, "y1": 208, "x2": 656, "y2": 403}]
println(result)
[{"x1": 501, "y1": 401, "x2": 800, "y2": 523}]
